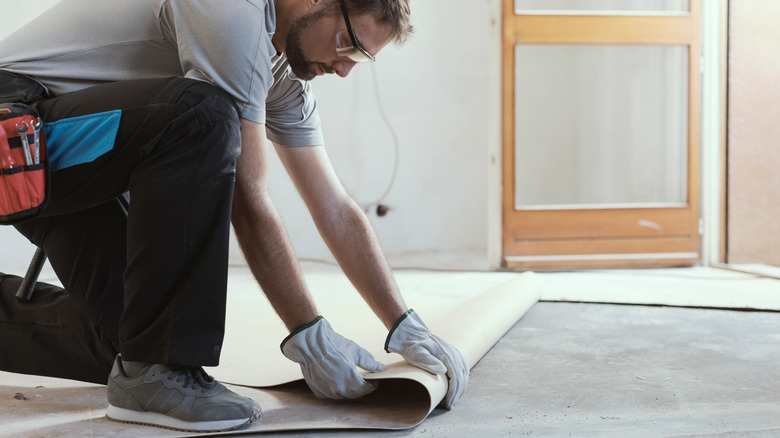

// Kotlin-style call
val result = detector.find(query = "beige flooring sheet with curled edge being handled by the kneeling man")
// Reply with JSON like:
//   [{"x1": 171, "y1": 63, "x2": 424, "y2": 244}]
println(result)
[{"x1": 0, "y1": 270, "x2": 542, "y2": 437}]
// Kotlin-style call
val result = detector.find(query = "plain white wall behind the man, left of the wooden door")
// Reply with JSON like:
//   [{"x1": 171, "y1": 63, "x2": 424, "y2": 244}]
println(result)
[{"x1": 0, "y1": 0, "x2": 500, "y2": 272}]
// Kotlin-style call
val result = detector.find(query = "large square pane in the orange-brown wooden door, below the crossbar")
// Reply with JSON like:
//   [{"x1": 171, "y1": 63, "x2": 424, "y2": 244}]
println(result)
[{"x1": 515, "y1": 44, "x2": 688, "y2": 210}]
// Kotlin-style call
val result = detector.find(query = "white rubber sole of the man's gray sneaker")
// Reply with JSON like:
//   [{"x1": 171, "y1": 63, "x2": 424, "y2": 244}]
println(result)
[{"x1": 106, "y1": 404, "x2": 260, "y2": 432}]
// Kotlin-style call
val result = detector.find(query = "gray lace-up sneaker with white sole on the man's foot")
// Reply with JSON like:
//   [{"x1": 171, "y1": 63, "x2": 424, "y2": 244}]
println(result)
[{"x1": 106, "y1": 356, "x2": 260, "y2": 432}]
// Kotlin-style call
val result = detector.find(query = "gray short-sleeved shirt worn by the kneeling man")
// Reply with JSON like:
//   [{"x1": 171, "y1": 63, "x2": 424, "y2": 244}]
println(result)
[{"x1": 0, "y1": 0, "x2": 323, "y2": 146}]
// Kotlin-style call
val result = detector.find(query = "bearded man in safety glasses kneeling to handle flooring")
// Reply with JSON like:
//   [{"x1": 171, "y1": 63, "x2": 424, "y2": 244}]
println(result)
[{"x1": 0, "y1": 0, "x2": 468, "y2": 431}]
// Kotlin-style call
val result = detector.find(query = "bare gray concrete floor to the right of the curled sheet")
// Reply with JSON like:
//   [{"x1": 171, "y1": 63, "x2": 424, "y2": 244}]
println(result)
[{"x1": 265, "y1": 302, "x2": 780, "y2": 438}]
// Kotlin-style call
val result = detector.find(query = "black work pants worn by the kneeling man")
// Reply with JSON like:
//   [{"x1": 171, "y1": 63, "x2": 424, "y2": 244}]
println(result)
[{"x1": 0, "y1": 72, "x2": 240, "y2": 383}]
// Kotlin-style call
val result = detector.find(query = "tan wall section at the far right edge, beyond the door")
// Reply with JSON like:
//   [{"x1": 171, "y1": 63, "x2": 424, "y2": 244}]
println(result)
[{"x1": 727, "y1": 0, "x2": 780, "y2": 265}]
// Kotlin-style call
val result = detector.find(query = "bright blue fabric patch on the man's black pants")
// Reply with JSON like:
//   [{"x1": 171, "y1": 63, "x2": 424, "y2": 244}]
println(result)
[{"x1": 43, "y1": 110, "x2": 122, "y2": 172}]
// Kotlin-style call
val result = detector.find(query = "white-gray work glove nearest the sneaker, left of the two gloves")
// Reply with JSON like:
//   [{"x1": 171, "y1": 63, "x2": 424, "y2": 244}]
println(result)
[{"x1": 281, "y1": 316, "x2": 385, "y2": 399}]
